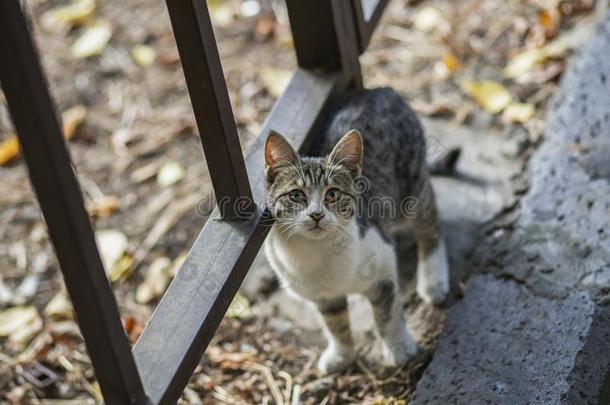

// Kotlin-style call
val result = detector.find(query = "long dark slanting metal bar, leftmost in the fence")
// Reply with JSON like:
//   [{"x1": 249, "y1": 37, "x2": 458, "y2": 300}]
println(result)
[{"x1": 0, "y1": 0, "x2": 146, "y2": 404}]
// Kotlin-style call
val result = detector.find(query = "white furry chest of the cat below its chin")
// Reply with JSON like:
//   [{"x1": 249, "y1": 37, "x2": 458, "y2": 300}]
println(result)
[{"x1": 265, "y1": 221, "x2": 396, "y2": 300}]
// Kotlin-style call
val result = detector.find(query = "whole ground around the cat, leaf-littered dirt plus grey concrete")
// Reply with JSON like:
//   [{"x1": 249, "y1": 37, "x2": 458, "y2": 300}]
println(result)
[{"x1": 0, "y1": 0, "x2": 610, "y2": 404}]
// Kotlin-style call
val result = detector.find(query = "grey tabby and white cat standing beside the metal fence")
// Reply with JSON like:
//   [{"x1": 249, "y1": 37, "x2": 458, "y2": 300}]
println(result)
[{"x1": 264, "y1": 88, "x2": 449, "y2": 373}]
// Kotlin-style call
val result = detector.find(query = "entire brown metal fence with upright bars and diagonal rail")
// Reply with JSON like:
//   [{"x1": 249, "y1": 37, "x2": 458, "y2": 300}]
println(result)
[{"x1": 0, "y1": 0, "x2": 387, "y2": 404}]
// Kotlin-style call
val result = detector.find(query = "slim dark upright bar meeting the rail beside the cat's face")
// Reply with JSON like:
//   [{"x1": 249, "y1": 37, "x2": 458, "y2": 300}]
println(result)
[{"x1": 167, "y1": 0, "x2": 254, "y2": 219}]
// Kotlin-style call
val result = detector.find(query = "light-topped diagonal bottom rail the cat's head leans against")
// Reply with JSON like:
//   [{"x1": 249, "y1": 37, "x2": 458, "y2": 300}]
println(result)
[{"x1": 134, "y1": 70, "x2": 345, "y2": 404}]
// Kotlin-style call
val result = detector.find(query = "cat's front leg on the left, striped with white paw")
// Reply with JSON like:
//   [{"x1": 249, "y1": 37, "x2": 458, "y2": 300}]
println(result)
[{"x1": 315, "y1": 296, "x2": 355, "y2": 374}]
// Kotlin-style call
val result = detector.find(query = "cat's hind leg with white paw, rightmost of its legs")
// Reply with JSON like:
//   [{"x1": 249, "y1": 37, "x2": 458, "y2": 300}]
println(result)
[{"x1": 413, "y1": 179, "x2": 449, "y2": 304}]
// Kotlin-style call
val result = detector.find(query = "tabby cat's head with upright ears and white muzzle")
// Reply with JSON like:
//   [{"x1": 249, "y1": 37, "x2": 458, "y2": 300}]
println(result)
[{"x1": 265, "y1": 130, "x2": 362, "y2": 239}]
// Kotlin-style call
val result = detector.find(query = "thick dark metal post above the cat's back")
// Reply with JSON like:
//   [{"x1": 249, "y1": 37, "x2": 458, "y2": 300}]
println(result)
[{"x1": 286, "y1": 0, "x2": 362, "y2": 87}]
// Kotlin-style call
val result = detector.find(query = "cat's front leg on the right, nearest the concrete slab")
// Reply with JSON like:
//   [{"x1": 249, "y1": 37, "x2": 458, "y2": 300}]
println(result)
[{"x1": 366, "y1": 280, "x2": 417, "y2": 367}]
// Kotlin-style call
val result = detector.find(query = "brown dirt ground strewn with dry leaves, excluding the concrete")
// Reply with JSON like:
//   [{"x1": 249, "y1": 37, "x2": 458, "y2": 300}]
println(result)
[{"x1": 0, "y1": 0, "x2": 594, "y2": 404}]
